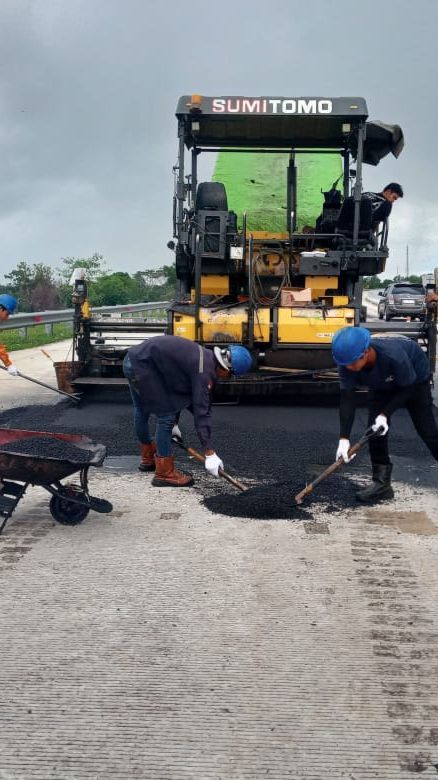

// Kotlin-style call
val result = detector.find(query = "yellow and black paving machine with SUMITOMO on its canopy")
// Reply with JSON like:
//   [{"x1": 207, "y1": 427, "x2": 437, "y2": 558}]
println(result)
[{"x1": 168, "y1": 94, "x2": 434, "y2": 393}]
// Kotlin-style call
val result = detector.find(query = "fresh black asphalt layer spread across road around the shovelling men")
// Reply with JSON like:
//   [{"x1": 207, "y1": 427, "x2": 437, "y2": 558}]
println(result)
[{"x1": 0, "y1": 397, "x2": 438, "y2": 520}]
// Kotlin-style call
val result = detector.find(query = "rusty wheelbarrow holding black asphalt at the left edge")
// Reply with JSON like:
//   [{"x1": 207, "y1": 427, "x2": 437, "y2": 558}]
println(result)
[{"x1": 0, "y1": 428, "x2": 113, "y2": 533}]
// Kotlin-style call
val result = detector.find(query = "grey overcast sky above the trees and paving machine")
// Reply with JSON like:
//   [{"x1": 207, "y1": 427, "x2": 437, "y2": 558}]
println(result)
[{"x1": 0, "y1": 0, "x2": 438, "y2": 275}]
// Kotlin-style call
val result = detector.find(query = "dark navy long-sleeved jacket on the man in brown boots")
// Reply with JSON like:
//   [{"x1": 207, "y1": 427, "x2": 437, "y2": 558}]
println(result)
[{"x1": 128, "y1": 336, "x2": 217, "y2": 448}]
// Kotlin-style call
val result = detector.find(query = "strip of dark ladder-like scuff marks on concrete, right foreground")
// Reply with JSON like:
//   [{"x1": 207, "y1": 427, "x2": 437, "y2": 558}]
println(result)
[{"x1": 351, "y1": 518, "x2": 438, "y2": 776}]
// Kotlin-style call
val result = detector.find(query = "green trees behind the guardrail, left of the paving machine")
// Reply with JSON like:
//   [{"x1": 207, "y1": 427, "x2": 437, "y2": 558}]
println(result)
[{"x1": 0, "y1": 252, "x2": 176, "y2": 312}]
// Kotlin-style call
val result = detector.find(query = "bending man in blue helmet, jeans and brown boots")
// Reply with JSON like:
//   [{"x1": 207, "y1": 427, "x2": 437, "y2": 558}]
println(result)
[{"x1": 123, "y1": 336, "x2": 252, "y2": 487}]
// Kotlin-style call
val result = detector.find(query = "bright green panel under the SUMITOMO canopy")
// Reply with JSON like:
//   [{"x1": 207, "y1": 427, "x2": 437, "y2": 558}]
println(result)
[{"x1": 213, "y1": 152, "x2": 342, "y2": 233}]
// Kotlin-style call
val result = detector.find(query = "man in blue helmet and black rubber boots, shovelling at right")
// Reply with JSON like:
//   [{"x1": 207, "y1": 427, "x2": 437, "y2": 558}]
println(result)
[{"x1": 332, "y1": 327, "x2": 438, "y2": 503}]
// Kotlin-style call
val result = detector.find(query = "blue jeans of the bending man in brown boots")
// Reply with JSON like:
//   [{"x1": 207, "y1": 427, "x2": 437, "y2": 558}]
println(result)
[{"x1": 123, "y1": 355, "x2": 179, "y2": 458}]
